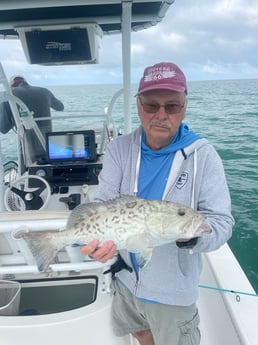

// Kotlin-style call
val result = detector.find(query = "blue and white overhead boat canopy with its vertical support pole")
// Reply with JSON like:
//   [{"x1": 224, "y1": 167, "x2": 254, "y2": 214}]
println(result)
[{"x1": 0, "y1": 0, "x2": 175, "y2": 133}]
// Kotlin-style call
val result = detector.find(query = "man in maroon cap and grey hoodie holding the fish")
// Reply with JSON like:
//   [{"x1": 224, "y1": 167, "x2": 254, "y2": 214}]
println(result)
[{"x1": 81, "y1": 63, "x2": 234, "y2": 345}]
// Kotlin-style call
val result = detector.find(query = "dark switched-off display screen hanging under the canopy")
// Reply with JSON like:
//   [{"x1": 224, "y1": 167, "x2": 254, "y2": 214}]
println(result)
[{"x1": 25, "y1": 28, "x2": 92, "y2": 64}]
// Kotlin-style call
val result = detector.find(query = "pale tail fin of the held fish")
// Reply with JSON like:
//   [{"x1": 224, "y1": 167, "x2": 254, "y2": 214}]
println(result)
[{"x1": 14, "y1": 230, "x2": 62, "y2": 272}]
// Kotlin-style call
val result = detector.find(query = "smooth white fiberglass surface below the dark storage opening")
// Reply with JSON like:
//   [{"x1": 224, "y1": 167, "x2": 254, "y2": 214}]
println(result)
[{"x1": 0, "y1": 282, "x2": 132, "y2": 345}]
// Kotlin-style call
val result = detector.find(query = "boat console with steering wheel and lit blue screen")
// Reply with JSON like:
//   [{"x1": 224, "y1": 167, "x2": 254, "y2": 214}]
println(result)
[{"x1": 5, "y1": 130, "x2": 102, "y2": 211}]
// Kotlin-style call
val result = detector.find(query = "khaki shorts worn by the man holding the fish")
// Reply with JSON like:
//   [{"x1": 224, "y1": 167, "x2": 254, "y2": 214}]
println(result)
[{"x1": 112, "y1": 279, "x2": 200, "y2": 345}]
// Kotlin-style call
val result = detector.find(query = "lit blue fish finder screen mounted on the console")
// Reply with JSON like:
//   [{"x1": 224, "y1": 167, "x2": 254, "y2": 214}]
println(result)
[{"x1": 47, "y1": 130, "x2": 97, "y2": 163}]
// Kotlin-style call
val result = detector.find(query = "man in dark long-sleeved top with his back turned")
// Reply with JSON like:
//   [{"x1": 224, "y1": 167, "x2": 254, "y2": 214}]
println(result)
[{"x1": 0, "y1": 75, "x2": 64, "y2": 162}]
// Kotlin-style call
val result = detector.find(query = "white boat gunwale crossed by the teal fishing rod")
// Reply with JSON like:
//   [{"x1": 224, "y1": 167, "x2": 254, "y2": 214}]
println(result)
[{"x1": 198, "y1": 245, "x2": 258, "y2": 345}]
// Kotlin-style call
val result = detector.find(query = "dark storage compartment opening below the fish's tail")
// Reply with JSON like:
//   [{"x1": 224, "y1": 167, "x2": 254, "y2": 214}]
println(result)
[{"x1": 19, "y1": 276, "x2": 98, "y2": 315}]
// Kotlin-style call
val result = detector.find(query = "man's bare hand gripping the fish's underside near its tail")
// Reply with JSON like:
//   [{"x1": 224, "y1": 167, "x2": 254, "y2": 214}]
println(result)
[{"x1": 81, "y1": 240, "x2": 117, "y2": 263}]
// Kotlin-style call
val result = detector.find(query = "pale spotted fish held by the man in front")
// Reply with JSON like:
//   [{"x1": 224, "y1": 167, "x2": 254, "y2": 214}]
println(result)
[{"x1": 14, "y1": 195, "x2": 211, "y2": 272}]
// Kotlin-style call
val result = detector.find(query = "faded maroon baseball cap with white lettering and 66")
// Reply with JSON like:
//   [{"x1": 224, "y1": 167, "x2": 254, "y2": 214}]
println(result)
[{"x1": 136, "y1": 62, "x2": 187, "y2": 96}]
